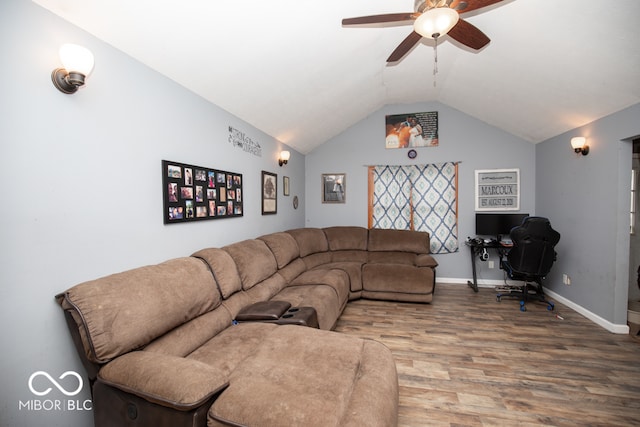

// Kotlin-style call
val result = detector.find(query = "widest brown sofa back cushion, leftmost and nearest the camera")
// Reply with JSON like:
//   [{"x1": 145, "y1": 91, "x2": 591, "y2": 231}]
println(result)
[{"x1": 57, "y1": 257, "x2": 221, "y2": 363}]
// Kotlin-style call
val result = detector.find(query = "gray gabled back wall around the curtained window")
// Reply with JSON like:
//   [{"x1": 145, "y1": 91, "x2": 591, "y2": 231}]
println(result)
[{"x1": 306, "y1": 102, "x2": 535, "y2": 284}]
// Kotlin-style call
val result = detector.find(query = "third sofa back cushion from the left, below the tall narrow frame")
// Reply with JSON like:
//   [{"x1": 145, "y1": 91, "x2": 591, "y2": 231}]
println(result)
[{"x1": 223, "y1": 239, "x2": 278, "y2": 290}]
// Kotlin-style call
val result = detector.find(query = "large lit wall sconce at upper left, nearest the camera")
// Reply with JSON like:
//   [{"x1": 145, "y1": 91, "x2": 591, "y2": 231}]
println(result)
[{"x1": 51, "y1": 44, "x2": 94, "y2": 94}]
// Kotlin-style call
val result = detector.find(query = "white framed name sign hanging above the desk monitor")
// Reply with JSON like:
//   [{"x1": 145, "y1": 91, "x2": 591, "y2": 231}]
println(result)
[{"x1": 475, "y1": 169, "x2": 520, "y2": 211}]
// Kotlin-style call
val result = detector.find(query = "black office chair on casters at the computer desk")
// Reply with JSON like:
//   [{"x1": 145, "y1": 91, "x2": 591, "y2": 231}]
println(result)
[{"x1": 497, "y1": 216, "x2": 560, "y2": 311}]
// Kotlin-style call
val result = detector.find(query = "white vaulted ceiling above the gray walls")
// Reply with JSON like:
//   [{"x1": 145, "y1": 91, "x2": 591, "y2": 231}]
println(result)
[{"x1": 34, "y1": 0, "x2": 640, "y2": 154}]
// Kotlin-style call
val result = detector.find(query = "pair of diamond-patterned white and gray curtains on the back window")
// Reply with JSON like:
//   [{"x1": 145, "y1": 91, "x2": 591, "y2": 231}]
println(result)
[{"x1": 371, "y1": 162, "x2": 458, "y2": 253}]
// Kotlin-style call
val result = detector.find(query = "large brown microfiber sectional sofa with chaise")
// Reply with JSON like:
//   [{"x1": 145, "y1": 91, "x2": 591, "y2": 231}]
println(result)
[{"x1": 56, "y1": 227, "x2": 437, "y2": 427}]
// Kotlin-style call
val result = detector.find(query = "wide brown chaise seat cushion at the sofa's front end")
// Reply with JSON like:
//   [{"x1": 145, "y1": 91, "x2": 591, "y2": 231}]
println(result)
[{"x1": 208, "y1": 326, "x2": 398, "y2": 427}]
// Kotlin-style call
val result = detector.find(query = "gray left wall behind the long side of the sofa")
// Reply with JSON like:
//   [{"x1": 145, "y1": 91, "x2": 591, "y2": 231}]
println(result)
[{"x1": 0, "y1": 0, "x2": 305, "y2": 427}]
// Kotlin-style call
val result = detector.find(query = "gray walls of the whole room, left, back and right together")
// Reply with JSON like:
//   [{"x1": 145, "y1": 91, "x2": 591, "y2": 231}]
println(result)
[{"x1": 0, "y1": 0, "x2": 640, "y2": 427}]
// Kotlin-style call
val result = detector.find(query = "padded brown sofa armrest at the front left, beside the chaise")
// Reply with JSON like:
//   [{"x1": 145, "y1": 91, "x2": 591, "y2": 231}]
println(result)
[{"x1": 98, "y1": 351, "x2": 229, "y2": 411}]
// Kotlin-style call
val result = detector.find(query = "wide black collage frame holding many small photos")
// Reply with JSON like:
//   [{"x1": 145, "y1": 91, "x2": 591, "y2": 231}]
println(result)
[{"x1": 162, "y1": 160, "x2": 243, "y2": 224}]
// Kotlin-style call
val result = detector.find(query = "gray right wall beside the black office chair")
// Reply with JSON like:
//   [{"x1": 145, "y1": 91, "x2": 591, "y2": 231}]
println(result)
[{"x1": 536, "y1": 104, "x2": 640, "y2": 325}]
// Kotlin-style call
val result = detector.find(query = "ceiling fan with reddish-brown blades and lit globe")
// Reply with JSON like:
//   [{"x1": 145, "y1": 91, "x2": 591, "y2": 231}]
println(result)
[{"x1": 342, "y1": 0, "x2": 503, "y2": 62}]
